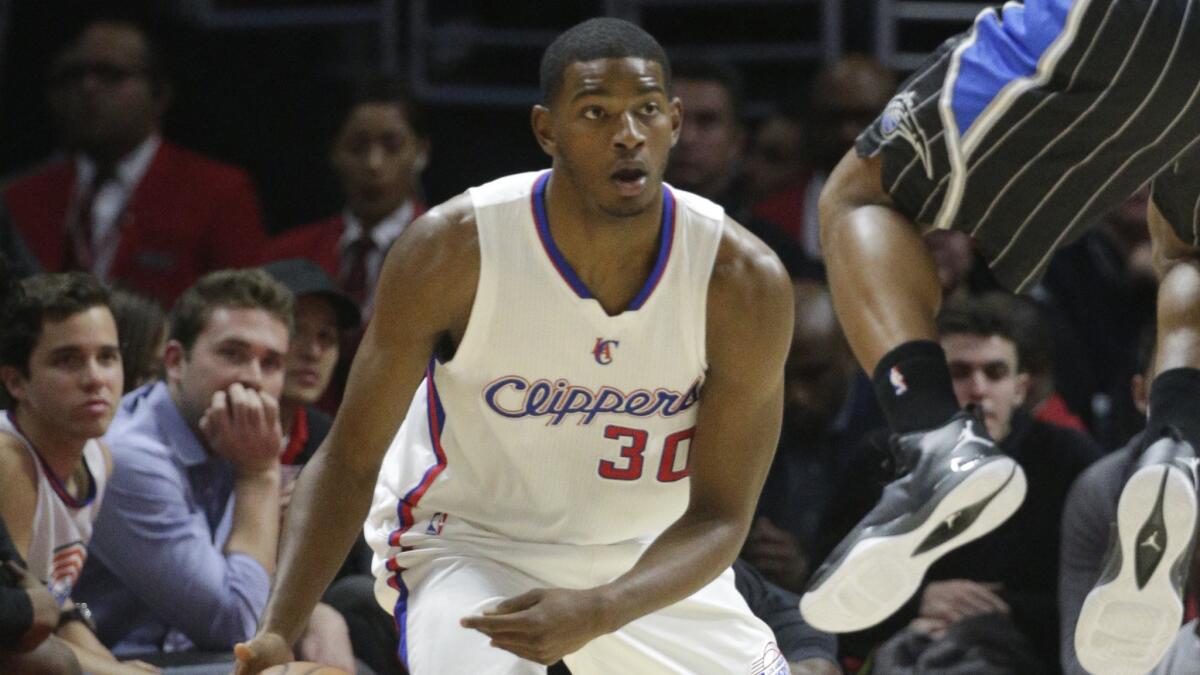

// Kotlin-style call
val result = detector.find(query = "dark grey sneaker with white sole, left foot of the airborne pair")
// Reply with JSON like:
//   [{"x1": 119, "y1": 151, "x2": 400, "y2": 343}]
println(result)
[{"x1": 800, "y1": 411, "x2": 1025, "y2": 633}]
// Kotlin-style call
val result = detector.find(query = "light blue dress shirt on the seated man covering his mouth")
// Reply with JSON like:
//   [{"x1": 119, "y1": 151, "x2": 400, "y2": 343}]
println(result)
[{"x1": 74, "y1": 382, "x2": 270, "y2": 656}]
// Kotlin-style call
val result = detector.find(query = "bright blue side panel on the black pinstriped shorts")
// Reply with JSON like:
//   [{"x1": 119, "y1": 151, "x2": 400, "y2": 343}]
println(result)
[{"x1": 950, "y1": 0, "x2": 1072, "y2": 137}]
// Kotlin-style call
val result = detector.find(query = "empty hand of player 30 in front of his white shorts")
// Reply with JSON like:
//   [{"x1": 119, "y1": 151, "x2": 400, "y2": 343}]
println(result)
[{"x1": 460, "y1": 589, "x2": 610, "y2": 665}]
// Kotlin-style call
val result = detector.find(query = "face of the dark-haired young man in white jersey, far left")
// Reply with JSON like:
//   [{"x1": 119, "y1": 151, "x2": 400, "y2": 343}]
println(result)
[{"x1": 5, "y1": 306, "x2": 124, "y2": 441}]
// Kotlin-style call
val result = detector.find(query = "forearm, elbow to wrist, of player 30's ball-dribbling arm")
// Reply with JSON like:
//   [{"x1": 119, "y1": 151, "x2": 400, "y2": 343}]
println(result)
[{"x1": 262, "y1": 447, "x2": 378, "y2": 645}]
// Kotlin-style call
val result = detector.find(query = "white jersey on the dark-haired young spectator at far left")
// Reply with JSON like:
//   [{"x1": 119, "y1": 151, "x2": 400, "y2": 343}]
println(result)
[{"x1": 0, "y1": 412, "x2": 108, "y2": 604}]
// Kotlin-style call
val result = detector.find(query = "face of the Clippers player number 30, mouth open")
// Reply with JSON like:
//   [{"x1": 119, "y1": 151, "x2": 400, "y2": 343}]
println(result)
[{"x1": 535, "y1": 58, "x2": 680, "y2": 217}]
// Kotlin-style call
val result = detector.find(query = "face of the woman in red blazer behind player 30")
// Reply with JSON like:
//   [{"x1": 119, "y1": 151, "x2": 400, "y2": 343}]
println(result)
[{"x1": 331, "y1": 103, "x2": 428, "y2": 222}]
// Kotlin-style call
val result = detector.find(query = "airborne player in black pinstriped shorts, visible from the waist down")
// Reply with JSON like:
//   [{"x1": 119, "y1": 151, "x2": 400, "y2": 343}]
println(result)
[{"x1": 802, "y1": 0, "x2": 1200, "y2": 673}]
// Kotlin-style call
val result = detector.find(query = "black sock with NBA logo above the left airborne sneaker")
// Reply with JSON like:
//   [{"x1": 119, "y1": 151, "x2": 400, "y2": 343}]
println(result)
[{"x1": 871, "y1": 340, "x2": 959, "y2": 434}]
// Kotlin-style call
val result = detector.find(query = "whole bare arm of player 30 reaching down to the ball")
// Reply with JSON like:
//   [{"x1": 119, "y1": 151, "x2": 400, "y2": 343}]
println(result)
[{"x1": 235, "y1": 196, "x2": 479, "y2": 674}]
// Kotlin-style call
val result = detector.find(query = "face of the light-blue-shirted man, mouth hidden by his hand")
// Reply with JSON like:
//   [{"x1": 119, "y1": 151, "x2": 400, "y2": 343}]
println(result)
[{"x1": 164, "y1": 307, "x2": 288, "y2": 425}]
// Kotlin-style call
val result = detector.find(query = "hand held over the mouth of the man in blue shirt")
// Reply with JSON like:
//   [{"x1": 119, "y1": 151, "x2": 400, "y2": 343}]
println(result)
[{"x1": 200, "y1": 382, "x2": 283, "y2": 473}]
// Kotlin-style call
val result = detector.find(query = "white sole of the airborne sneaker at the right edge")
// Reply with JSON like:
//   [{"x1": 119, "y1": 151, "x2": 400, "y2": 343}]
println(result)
[{"x1": 1075, "y1": 465, "x2": 1196, "y2": 675}]
